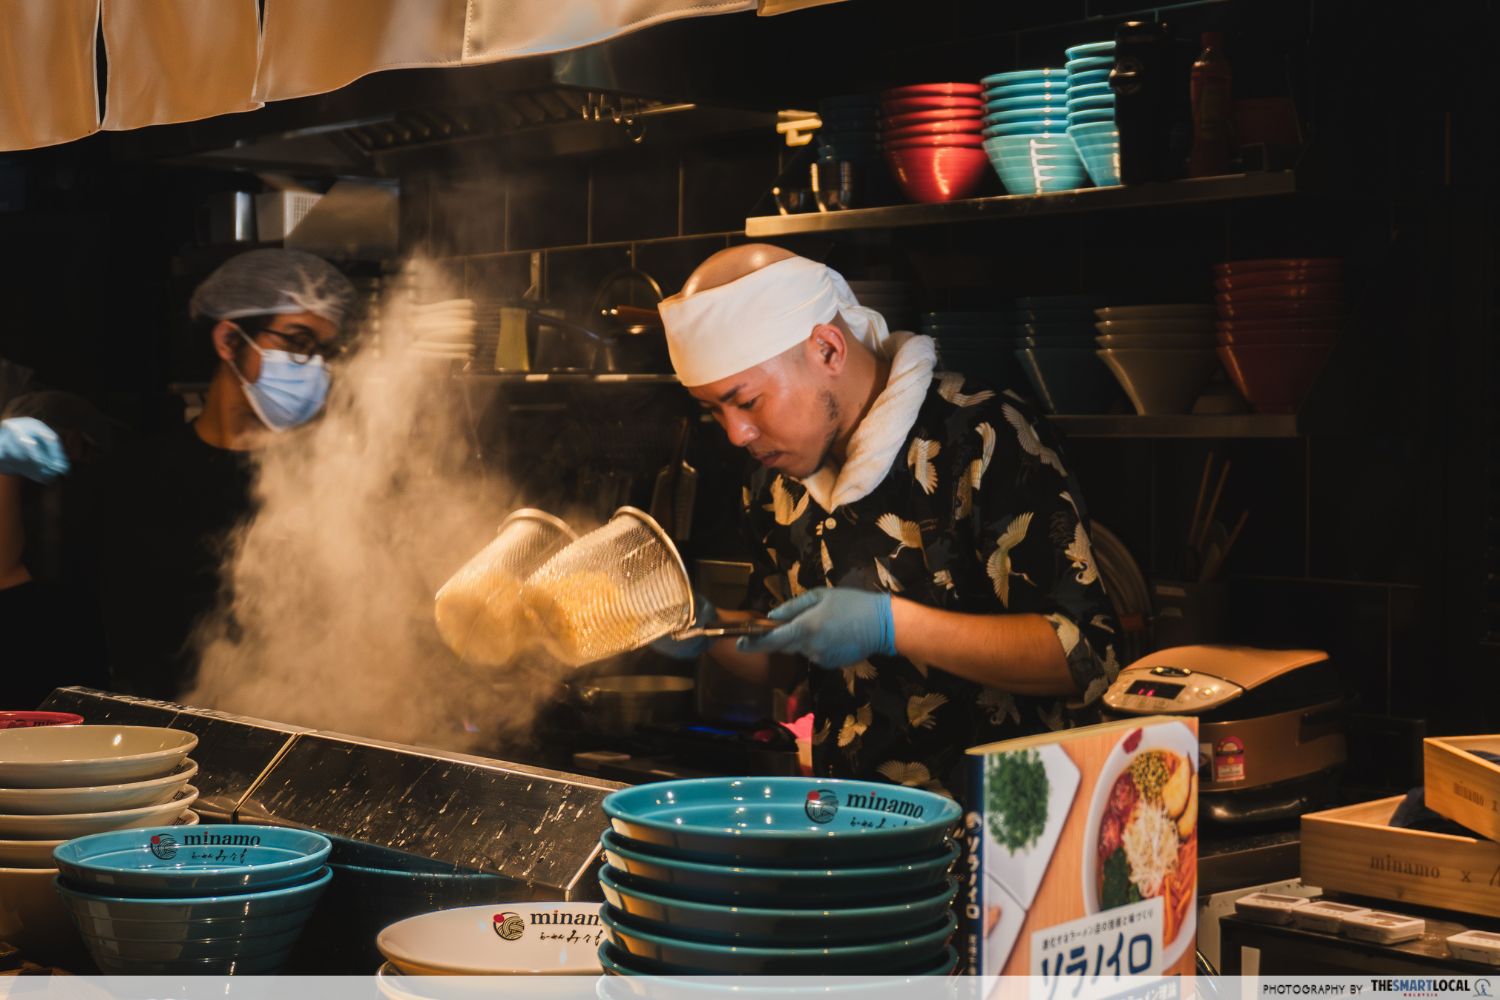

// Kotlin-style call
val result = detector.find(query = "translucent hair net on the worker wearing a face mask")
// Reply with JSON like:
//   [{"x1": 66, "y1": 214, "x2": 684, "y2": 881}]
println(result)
[{"x1": 189, "y1": 249, "x2": 354, "y2": 327}]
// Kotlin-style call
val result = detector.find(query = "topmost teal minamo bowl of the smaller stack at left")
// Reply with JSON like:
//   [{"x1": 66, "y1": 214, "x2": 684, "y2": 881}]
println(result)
[{"x1": 53, "y1": 825, "x2": 333, "y2": 897}]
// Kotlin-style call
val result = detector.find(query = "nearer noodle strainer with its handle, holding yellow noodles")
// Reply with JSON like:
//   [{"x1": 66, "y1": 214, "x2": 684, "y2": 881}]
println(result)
[{"x1": 525, "y1": 507, "x2": 776, "y2": 667}]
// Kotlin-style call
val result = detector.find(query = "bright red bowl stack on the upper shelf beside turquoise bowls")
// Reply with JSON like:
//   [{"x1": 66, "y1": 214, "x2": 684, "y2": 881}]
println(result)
[{"x1": 881, "y1": 84, "x2": 990, "y2": 202}]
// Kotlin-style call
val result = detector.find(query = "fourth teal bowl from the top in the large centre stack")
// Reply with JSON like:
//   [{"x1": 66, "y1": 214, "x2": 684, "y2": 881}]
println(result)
[{"x1": 599, "y1": 905, "x2": 954, "y2": 976}]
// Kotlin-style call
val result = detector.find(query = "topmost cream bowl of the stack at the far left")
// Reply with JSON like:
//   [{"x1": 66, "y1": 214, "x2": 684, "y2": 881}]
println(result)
[{"x1": 0, "y1": 726, "x2": 198, "y2": 789}]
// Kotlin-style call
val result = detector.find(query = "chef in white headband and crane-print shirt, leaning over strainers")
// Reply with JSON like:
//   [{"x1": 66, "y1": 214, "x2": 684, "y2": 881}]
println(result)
[{"x1": 656, "y1": 244, "x2": 1119, "y2": 801}]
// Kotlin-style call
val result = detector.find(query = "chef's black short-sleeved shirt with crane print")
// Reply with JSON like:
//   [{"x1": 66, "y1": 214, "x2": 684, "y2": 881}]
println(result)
[{"x1": 743, "y1": 372, "x2": 1119, "y2": 799}]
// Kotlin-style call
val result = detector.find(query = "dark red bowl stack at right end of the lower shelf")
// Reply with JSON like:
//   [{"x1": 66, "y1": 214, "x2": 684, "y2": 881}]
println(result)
[{"x1": 1214, "y1": 258, "x2": 1344, "y2": 414}]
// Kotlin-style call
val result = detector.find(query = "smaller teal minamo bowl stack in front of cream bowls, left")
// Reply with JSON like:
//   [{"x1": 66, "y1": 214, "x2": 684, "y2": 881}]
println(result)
[{"x1": 54, "y1": 825, "x2": 332, "y2": 976}]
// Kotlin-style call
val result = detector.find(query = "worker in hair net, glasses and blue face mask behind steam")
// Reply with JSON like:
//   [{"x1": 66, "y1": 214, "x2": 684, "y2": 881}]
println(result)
[{"x1": 80, "y1": 249, "x2": 354, "y2": 699}]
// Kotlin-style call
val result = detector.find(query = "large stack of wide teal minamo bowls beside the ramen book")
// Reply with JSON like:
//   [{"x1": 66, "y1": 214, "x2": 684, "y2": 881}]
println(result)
[{"x1": 588, "y1": 778, "x2": 962, "y2": 976}]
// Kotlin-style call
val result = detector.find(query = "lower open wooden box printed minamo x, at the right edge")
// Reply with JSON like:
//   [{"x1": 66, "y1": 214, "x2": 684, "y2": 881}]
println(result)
[{"x1": 1302, "y1": 795, "x2": 1500, "y2": 916}]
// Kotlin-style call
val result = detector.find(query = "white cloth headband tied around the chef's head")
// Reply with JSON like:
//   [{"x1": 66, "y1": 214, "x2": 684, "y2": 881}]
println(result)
[{"x1": 662, "y1": 256, "x2": 890, "y2": 387}]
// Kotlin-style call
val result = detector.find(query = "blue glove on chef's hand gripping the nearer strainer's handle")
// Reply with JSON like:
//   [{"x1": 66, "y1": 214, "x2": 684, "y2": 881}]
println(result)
[{"x1": 735, "y1": 586, "x2": 896, "y2": 670}]
